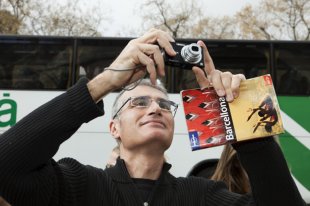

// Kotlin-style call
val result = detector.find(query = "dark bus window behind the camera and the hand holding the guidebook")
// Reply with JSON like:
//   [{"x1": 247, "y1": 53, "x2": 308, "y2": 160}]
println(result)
[{"x1": 164, "y1": 40, "x2": 271, "y2": 93}]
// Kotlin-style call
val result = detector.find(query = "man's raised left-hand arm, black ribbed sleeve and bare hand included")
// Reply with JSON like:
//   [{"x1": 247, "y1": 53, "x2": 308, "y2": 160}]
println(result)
[{"x1": 0, "y1": 29, "x2": 175, "y2": 206}]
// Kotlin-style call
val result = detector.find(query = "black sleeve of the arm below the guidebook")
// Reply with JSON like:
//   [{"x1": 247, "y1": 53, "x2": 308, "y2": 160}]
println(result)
[{"x1": 234, "y1": 137, "x2": 305, "y2": 206}]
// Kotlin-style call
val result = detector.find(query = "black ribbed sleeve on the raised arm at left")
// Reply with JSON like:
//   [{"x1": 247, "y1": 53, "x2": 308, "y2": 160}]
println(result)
[{"x1": 0, "y1": 79, "x2": 104, "y2": 206}]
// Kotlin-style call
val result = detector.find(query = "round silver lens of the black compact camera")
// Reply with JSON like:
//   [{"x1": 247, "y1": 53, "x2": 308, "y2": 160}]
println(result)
[{"x1": 181, "y1": 43, "x2": 202, "y2": 64}]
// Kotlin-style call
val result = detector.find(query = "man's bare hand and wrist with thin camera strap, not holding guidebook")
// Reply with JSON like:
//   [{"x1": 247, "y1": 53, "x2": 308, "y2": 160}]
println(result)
[{"x1": 87, "y1": 29, "x2": 176, "y2": 102}]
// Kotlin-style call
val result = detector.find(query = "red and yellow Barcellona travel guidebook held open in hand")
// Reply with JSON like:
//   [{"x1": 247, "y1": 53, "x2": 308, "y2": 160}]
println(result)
[{"x1": 181, "y1": 74, "x2": 284, "y2": 150}]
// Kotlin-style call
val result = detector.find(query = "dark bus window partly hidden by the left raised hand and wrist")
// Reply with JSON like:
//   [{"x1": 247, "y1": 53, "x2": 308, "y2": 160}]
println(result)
[{"x1": 76, "y1": 38, "x2": 129, "y2": 79}]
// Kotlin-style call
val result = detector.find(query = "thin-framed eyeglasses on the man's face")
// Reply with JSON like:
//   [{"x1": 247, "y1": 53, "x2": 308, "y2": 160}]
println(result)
[{"x1": 113, "y1": 96, "x2": 178, "y2": 119}]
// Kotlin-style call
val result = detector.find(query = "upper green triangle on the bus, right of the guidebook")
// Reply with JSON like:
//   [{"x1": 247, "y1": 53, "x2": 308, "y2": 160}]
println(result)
[{"x1": 277, "y1": 96, "x2": 310, "y2": 132}]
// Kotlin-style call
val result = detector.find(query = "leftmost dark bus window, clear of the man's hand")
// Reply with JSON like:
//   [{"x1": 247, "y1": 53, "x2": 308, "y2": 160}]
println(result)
[{"x1": 0, "y1": 36, "x2": 73, "y2": 90}]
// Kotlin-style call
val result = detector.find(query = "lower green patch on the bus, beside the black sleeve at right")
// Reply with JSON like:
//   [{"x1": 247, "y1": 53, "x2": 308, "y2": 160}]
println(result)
[{"x1": 279, "y1": 132, "x2": 310, "y2": 191}]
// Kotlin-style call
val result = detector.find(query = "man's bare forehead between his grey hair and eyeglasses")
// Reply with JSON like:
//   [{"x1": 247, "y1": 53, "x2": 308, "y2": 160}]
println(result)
[{"x1": 120, "y1": 85, "x2": 168, "y2": 102}]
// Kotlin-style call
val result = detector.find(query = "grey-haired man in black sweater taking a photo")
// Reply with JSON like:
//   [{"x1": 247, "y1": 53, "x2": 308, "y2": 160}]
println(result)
[{"x1": 0, "y1": 29, "x2": 303, "y2": 206}]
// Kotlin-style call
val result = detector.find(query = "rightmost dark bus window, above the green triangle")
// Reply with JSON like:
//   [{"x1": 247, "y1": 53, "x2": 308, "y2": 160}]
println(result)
[{"x1": 274, "y1": 42, "x2": 310, "y2": 95}]
